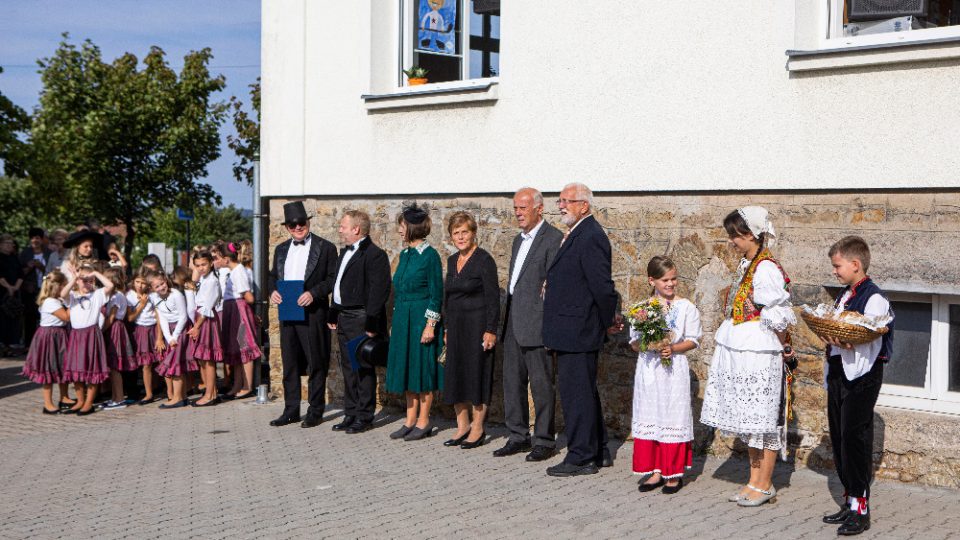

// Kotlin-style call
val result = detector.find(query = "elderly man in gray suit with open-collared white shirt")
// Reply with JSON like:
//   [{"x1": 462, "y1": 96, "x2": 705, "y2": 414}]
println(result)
[{"x1": 493, "y1": 188, "x2": 563, "y2": 461}]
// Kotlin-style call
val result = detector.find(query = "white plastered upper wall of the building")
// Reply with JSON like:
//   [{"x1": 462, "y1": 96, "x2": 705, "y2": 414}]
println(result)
[{"x1": 262, "y1": 0, "x2": 960, "y2": 196}]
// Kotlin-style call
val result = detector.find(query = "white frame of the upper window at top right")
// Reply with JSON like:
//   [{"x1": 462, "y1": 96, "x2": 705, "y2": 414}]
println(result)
[{"x1": 818, "y1": 0, "x2": 960, "y2": 51}]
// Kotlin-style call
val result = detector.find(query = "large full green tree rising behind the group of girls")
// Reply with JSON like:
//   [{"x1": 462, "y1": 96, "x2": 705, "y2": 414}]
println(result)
[{"x1": 31, "y1": 34, "x2": 227, "y2": 257}]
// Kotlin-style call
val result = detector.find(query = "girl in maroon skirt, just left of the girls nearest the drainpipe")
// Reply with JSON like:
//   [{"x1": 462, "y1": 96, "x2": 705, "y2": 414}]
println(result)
[{"x1": 187, "y1": 251, "x2": 223, "y2": 407}]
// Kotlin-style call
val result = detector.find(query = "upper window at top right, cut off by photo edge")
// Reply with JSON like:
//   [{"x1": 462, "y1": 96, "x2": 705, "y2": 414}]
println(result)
[{"x1": 823, "y1": 0, "x2": 960, "y2": 49}]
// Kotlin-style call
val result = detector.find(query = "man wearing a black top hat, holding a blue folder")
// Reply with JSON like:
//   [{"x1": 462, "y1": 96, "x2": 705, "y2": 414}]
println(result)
[{"x1": 268, "y1": 201, "x2": 337, "y2": 428}]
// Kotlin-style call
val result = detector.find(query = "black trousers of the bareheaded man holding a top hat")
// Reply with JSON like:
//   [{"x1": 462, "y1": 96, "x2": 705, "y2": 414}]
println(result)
[{"x1": 337, "y1": 309, "x2": 377, "y2": 422}]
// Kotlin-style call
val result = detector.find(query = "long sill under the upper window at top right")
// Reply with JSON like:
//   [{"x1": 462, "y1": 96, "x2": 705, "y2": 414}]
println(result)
[{"x1": 786, "y1": 36, "x2": 960, "y2": 72}]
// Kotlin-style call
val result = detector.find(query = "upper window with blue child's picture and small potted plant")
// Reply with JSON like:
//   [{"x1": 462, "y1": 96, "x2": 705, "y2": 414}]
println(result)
[{"x1": 399, "y1": 0, "x2": 500, "y2": 86}]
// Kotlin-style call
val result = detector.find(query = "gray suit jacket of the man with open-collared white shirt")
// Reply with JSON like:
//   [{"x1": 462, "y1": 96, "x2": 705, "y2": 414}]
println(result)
[{"x1": 503, "y1": 221, "x2": 563, "y2": 347}]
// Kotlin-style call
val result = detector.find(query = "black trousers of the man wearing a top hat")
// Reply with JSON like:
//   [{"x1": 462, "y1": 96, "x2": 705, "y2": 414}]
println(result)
[{"x1": 280, "y1": 310, "x2": 330, "y2": 418}]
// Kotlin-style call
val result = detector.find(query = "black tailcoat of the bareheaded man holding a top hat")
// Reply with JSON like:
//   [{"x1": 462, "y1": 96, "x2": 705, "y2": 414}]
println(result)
[{"x1": 328, "y1": 236, "x2": 392, "y2": 337}]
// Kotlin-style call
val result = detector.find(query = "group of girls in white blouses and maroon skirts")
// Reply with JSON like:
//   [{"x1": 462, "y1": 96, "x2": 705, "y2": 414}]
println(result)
[{"x1": 23, "y1": 241, "x2": 261, "y2": 416}]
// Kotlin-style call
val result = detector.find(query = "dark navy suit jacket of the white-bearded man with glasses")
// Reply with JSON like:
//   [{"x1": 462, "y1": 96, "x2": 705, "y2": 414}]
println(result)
[{"x1": 543, "y1": 215, "x2": 618, "y2": 352}]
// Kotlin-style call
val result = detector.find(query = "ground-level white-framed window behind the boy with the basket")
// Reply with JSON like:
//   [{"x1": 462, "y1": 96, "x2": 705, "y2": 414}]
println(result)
[{"x1": 878, "y1": 294, "x2": 960, "y2": 414}]
